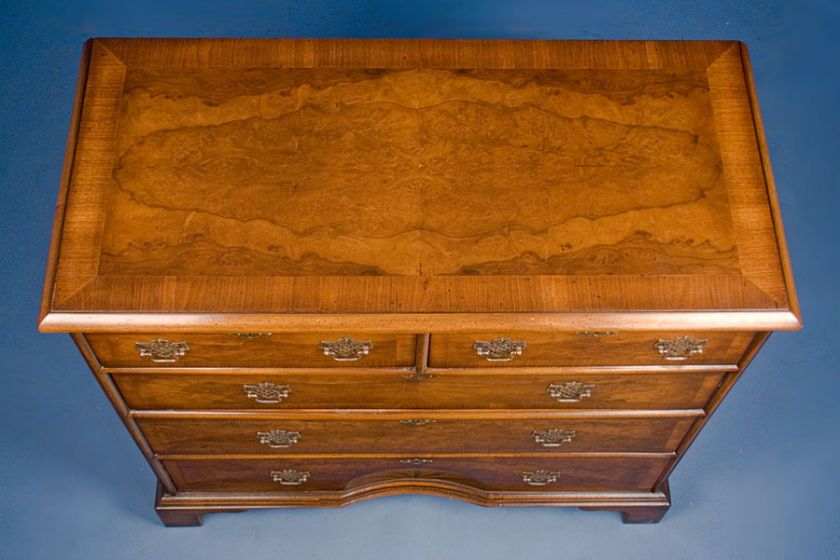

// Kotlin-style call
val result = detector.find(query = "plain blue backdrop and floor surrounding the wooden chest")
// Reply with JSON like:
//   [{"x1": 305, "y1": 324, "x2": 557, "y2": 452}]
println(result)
[{"x1": 0, "y1": 0, "x2": 840, "y2": 560}]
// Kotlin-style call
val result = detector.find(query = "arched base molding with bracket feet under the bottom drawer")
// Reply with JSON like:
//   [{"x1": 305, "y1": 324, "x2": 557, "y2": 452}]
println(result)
[{"x1": 155, "y1": 479, "x2": 671, "y2": 527}]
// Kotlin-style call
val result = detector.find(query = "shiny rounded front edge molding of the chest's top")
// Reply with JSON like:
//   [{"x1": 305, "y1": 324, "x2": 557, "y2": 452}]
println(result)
[{"x1": 38, "y1": 310, "x2": 802, "y2": 334}]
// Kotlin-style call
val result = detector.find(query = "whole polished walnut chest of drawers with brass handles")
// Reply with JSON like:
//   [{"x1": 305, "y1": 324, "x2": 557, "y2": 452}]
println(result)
[{"x1": 40, "y1": 39, "x2": 800, "y2": 525}]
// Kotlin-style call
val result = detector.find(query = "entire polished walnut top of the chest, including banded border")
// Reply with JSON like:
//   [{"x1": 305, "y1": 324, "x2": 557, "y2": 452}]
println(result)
[{"x1": 42, "y1": 39, "x2": 798, "y2": 330}]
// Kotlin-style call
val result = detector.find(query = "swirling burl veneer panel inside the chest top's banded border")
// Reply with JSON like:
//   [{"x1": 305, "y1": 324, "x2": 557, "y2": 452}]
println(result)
[{"x1": 99, "y1": 65, "x2": 738, "y2": 276}]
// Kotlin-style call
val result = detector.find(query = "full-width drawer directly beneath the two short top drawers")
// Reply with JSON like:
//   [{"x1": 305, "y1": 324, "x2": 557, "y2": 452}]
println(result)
[{"x1": 113, "y1": 370, "x2": 724, "y2": 410}]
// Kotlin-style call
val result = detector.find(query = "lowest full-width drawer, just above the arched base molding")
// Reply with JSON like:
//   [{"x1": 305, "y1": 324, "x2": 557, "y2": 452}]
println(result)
[{"x1": 164, "y1": 456, "x2": 670, "y2": 492}]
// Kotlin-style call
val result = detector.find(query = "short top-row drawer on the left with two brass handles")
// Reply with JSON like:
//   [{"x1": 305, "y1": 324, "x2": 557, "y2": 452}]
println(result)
[{"x1": 85, "y1": 333, "x2": 416, "y2": 368}]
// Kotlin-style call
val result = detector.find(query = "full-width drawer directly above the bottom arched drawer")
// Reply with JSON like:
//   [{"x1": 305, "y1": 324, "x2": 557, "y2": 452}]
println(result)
[{"x1": 138, "y1": 412, "x2": 697, "y2": 455}]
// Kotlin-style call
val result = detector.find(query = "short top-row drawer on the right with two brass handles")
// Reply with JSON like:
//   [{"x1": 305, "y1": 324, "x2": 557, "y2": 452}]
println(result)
[{"x1": 429, "y1": 331, "x2": 754, "y2": 368}]
